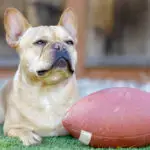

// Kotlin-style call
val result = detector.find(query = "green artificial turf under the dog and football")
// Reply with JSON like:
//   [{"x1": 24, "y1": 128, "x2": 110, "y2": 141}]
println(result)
[{"x1": 0, "y1": 126, "x2": 150, "y2": 150}]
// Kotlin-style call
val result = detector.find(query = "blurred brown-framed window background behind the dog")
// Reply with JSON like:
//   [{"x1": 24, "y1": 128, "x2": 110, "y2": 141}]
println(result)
[{"x1": 0, "y1": 0, "x2": 150, "y2": 90}]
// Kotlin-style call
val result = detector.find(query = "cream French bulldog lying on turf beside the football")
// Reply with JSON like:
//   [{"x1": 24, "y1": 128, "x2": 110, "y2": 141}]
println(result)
[{"x1": 0, "y1": 8, "x2": 79, "y2": 146}]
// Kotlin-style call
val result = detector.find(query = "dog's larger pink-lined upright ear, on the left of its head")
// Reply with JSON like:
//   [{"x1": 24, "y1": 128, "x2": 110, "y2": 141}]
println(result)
[{"x1": 4, "y1": 8, "x2": 31, "y2": 48}]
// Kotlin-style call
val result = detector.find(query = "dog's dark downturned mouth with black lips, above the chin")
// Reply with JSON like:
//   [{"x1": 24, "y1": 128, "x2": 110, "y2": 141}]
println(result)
[{"x1": 37, "y1": 57, "x2": 74, "y2": 76}]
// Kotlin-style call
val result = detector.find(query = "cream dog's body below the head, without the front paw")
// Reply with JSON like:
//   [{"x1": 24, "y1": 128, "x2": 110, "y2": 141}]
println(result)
[{"x1": 1, "y1": 71, "x2": 78, "y2": 136}]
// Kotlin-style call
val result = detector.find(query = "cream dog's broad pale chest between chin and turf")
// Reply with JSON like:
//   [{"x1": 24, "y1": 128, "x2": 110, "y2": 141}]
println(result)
[{"x1": 11, "y1": 74, "x2": 78, "y2": 136}]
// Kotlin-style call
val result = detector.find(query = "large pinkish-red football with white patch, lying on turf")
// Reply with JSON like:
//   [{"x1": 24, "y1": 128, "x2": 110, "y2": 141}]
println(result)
[{"x1": 63, "y1": 88, "x2": 150, "y2": 147}]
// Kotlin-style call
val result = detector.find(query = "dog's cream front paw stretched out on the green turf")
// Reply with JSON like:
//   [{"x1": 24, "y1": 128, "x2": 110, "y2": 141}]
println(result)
[{"x1": 8, "y1": 129, "x2": 42, "y2": 146}]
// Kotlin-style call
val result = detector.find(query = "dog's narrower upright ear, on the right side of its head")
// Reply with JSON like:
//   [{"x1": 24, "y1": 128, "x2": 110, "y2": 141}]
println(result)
[{"x1": 58, "y1": 8, "x2": 77, "y2": 38}]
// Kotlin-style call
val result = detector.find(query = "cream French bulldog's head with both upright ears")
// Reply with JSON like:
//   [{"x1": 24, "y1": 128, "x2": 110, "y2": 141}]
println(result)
[{"x1": 4, "y1": 8, "x2": 77, "y2": 85}]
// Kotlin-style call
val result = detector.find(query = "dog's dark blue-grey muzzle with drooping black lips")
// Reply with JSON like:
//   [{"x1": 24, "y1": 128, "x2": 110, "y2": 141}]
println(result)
[{"x1": 37, "y1": 42, "x2": 74, "y2": 76}]
